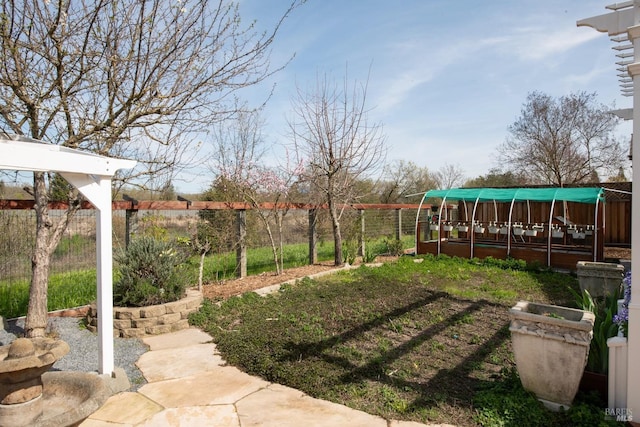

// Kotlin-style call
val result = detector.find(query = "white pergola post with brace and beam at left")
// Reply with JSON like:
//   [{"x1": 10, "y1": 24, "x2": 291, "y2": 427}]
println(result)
[{"x1": 0, "y1": 136, "x2": 136, "y2": 375}]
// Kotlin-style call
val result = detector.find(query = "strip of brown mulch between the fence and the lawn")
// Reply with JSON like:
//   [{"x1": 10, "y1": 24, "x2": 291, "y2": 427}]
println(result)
[{"x1": 202, "y1": 256, "x2": 398, "y2": 300}]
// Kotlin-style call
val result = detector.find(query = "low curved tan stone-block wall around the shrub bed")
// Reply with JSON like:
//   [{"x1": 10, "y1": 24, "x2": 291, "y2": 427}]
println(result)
[{"x1": 87, "y1": 289, "x2": 202, "y2": 338}]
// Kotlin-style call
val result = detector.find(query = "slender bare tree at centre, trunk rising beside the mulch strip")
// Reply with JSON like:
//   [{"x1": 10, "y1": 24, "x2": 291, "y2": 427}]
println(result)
[{"x1": 289, "y1": 71, "x2": 385, "y2": 265}]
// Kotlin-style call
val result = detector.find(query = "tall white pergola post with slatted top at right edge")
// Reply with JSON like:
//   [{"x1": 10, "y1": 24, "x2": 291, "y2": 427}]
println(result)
[{"x1": 577, "y1": 0, "x2": 640, "y2": 416}]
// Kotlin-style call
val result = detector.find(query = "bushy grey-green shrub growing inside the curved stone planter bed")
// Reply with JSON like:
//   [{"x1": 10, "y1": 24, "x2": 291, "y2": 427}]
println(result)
[{"x1": 113, "y1": 236, "x2": 187, "y2": 307}]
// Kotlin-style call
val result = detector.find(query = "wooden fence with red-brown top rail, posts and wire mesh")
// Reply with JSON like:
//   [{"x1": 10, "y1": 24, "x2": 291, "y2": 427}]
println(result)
[{"x1": 0, "y1": 200, "x2": 418, "y2": 284}]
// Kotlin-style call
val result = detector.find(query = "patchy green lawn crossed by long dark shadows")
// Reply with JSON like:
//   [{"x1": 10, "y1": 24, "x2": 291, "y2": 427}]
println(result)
[{"x1": 191, "y1": 256, "x2": 620, "y2": 426}]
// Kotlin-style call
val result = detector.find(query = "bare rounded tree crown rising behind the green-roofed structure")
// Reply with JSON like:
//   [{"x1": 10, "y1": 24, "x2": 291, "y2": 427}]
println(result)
[{"x1": 499, "y1": 92, "x2": 626, "y2": 186}]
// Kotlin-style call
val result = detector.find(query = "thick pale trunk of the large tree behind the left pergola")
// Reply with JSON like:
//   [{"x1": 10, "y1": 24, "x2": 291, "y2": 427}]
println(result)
[{"x1": 24, "y1": 172, "x2": 52, "y2": 338}]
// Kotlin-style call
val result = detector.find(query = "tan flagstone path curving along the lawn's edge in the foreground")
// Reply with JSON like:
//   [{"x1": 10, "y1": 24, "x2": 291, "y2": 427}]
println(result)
[{"x1": 80, "y1": 328, "x2": 456, "y2": 427}]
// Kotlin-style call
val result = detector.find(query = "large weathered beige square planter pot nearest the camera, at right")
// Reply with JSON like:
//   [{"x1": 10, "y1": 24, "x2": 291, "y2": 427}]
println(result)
[{"x1": 509, "y1": 301, "x2": 595, "y2": 411}]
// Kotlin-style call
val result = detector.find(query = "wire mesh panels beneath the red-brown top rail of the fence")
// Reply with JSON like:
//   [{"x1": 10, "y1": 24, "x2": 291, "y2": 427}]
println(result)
[{"x1": 0, "y1": 205, "x2": 417, "y2": 284}]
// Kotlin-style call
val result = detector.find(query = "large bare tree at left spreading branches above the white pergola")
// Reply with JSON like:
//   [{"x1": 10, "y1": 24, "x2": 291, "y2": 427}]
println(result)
[{"x1": 0, "y1": 0, "x2": 298, "y2": 337}]
